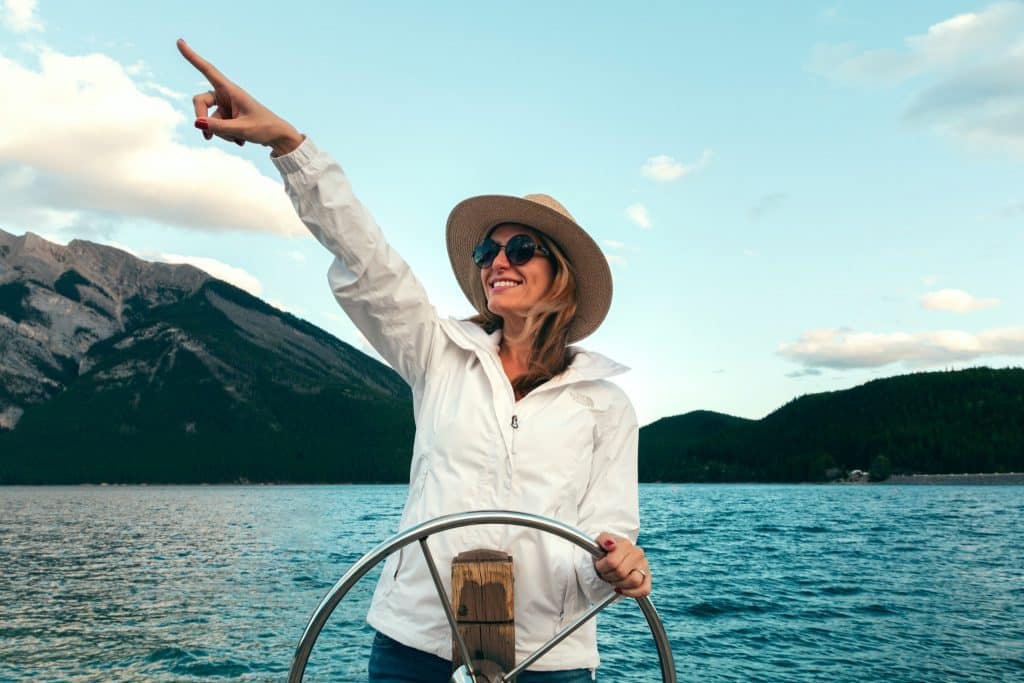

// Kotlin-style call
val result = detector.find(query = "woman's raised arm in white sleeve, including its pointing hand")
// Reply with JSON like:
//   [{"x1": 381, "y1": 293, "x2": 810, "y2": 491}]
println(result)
[{"x1": 177, "y1": 40, "x2": 438, "y2": 386}]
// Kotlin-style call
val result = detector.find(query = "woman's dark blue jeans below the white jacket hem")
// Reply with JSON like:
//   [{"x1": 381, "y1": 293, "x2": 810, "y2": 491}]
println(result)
[{"x1": 370, "y1": 633, "x2": 597, "y2": 683}]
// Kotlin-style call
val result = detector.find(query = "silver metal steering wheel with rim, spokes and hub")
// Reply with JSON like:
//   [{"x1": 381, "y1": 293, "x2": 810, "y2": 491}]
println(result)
[{"x1": 288, "y1": 510, "x2": 676, "y2": 683}]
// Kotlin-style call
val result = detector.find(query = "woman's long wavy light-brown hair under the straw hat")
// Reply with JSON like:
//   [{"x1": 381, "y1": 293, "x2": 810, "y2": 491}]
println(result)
[{"x1": 469, "y1": 223, "x2": 577, "y2": 398}]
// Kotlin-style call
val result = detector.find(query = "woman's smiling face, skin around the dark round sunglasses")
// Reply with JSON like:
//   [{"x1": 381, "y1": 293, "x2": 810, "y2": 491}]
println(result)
[{"x1": 480, "y1": 223, "x2": 554, "y2": 321}]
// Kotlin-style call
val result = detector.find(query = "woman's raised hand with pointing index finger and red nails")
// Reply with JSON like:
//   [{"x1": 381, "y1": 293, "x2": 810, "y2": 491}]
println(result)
[{"x1": 178, "y1": 40, "x2": 303, "y2": 157}]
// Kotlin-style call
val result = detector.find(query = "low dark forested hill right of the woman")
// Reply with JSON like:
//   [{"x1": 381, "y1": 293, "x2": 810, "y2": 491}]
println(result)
[{"x1": 640, "y1": 368, "x2": 1024, "y2": 481}]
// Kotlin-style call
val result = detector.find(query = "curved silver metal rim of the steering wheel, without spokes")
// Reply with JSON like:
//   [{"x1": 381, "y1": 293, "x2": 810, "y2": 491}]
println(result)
[{"x1": 288, "y1": 510, "x2": 676, "y2": 683}]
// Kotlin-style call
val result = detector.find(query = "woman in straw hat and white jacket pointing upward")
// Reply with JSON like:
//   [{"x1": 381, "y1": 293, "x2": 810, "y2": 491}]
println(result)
[{"x1": 178, "y1": 41, "x2": 651, "y2": 683}]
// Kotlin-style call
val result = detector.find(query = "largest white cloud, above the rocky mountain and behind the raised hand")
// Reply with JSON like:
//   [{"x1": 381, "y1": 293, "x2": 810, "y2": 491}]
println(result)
[{"x1": 0, "y1": 48, "x2": 306, "y2": 236}]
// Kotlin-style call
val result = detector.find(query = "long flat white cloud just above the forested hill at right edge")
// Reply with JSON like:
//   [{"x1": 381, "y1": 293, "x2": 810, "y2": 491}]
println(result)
[{"x1": 778, "y1": 327, "x2": 1024, "y2": 370}]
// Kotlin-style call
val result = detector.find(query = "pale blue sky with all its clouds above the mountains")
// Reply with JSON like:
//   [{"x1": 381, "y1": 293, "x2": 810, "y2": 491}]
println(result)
[{"x1": 0, "y1": 0, "x2": 1024, "y2": 423}]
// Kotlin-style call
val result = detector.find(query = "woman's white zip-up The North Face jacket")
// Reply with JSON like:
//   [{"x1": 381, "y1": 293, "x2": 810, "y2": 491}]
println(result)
[{"x1": 273, "y1": 140, "x2": 639, "y2": 671}]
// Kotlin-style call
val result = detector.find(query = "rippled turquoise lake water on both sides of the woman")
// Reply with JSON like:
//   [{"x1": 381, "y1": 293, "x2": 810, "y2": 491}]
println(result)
[{"x1": 0, "y1": 484, "x2": 1024, "y2": 682}]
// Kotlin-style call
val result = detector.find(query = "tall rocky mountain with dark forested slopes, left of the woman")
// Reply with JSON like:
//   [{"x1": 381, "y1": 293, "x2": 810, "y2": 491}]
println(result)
[{"x1": 0, "y1": 230, "x2": 413, "y2": 483}]
